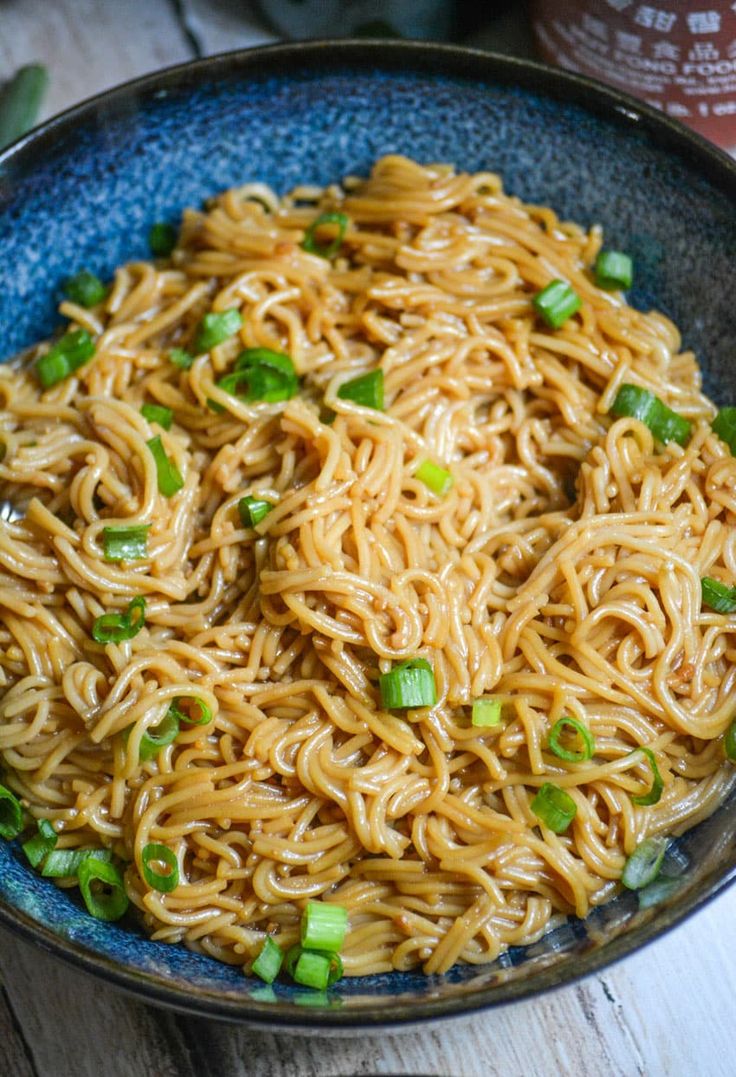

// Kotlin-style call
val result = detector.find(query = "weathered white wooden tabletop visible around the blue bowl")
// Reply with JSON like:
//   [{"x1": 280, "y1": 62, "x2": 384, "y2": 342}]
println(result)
[{"x1": 0, "y1": 0, "x2": 736, "y2": 1077}]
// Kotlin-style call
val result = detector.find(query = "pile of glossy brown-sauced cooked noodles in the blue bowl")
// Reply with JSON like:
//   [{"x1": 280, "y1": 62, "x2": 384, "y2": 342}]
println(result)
[{"x1": 0, "y1": 157, "x2": 736, "y2": 976}]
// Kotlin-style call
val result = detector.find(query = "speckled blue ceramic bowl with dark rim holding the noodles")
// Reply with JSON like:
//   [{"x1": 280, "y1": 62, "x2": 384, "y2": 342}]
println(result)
[{"x1": 0, "y1": 41, "x2": 736, "y2": 1030}]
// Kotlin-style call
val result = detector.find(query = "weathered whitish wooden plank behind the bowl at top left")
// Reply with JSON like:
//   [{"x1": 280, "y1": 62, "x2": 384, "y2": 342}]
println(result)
[{"x1": 0, "y1": 0, "x2": 193, "y2": 118}]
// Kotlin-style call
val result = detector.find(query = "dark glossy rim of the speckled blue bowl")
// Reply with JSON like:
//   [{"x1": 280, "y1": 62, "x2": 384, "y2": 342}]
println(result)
[{"x1": 0, "y1": 39, "x2": 736, "y2": 1033}]
